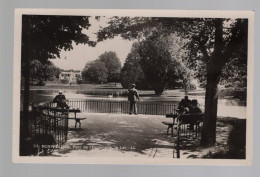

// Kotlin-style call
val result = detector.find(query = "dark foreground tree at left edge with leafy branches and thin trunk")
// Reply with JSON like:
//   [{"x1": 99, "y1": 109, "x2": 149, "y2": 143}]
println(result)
[{"x1": 21, "y1": 15, "x2": 95, "y2": 136}]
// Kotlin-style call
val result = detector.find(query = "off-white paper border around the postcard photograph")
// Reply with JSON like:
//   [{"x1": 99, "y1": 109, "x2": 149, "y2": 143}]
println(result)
[{"x1": 12, "y1": 9, "x2": 254, "y2": 166}]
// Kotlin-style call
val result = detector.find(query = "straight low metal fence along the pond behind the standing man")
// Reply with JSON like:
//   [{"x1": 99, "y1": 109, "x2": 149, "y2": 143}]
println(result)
[{"x1": 68, "y1": 99, "x2": 177, "y2": 115}]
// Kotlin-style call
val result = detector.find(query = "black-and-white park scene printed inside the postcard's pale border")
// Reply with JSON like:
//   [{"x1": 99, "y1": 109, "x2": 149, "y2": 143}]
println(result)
[{"x1": 15, "y1": 9, "x2": 252, "y2": 161}]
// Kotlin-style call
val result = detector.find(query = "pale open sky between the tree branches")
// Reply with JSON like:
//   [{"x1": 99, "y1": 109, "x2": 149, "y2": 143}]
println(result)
[{"x1": 51, "y1": 17, "x2": 134, "y2": 70}]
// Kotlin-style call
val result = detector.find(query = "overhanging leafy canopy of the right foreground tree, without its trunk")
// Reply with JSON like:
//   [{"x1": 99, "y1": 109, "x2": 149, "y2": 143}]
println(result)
[{"x1": 98, "y1": 17, "x2": 248, "y2": 70}]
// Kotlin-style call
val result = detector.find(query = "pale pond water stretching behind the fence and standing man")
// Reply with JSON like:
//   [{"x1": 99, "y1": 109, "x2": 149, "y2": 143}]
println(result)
[{"x1": 21, "y1": 89, "x2": 246, "y2": 118}]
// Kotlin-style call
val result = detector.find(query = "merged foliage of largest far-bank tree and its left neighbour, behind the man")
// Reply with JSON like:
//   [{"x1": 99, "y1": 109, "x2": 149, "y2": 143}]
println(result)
[{"x1": 121, "y1": 32, "x2": 188, "y2": 95}]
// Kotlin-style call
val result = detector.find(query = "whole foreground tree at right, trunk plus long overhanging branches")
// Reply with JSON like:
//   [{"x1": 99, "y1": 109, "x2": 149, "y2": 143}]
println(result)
[{"x1": 98, "y1": 17, "x2": 248, "y2": 146}]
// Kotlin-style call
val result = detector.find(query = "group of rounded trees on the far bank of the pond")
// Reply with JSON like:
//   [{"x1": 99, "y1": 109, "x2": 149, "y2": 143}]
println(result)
[{"x1": 82, "y1": 33, "x2": 192, "y2": 95}]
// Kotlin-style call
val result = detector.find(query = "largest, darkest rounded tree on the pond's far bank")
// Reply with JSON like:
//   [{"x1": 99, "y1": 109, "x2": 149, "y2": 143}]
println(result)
[{"x1": 138, "y1": 32, "x2": 185, "y2": 95}]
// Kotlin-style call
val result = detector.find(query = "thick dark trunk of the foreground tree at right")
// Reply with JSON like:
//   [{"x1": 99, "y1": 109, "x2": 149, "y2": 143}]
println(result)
[{"x1": 201, "y1": 19, "x2": 225, "y2": 147}]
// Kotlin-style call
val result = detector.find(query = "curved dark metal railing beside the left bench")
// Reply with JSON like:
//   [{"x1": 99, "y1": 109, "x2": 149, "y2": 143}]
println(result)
[{"x1": 30, "y1": 104, "x2": 68, "y2": 155}]
